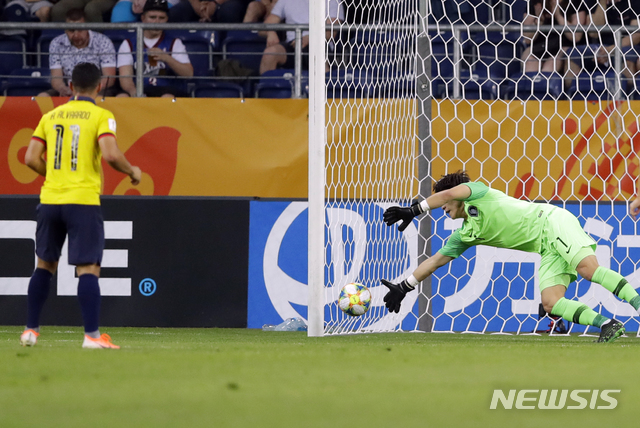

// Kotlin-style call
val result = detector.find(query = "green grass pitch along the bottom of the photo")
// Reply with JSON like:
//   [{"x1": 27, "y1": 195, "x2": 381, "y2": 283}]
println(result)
[{"x1": 0, "y1": 326, "x2": 640, "y2": 428}]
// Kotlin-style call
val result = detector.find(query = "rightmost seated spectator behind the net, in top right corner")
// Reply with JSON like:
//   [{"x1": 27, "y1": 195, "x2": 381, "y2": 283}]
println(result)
[{"x1": 569, "y1": 0, "x2": 640, "y2": 81}]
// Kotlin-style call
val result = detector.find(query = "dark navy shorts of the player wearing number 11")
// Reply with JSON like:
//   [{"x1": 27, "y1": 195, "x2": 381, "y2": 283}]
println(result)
[{"x1": 36, "y1": 204, "x2": 104, "y2": 265}]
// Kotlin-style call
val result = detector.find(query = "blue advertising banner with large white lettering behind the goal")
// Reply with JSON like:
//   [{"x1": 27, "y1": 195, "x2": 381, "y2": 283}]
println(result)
[{"x1": 247, "y1": 201, "x2": 640, "y2": 332}]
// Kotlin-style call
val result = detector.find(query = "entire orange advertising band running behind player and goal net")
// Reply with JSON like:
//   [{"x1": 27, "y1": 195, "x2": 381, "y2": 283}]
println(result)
[{"x1": 0, "y1": 97, "x2": 640, "y2": 200}]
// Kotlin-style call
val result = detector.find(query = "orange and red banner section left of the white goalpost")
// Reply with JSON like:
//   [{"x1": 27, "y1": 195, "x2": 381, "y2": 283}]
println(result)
[{"x1": 0, "y1": 97, "x2": 308, "y2": 198}]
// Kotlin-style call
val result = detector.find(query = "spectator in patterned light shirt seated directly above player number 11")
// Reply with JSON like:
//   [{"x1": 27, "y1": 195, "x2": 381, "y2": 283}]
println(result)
[{"x1": 39, "y1": 9, "x2": 116, "y2": 97}]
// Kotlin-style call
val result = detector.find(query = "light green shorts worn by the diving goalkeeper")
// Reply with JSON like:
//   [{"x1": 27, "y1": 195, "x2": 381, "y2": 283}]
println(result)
[{"x1": 538, "y1": 208, "x2": 596, "y2": 292}]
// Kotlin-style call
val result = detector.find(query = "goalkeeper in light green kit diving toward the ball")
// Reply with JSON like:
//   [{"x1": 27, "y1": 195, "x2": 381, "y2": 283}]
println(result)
[{"x1": 381, "y1": 171, "x2": 640, "y2": 342}]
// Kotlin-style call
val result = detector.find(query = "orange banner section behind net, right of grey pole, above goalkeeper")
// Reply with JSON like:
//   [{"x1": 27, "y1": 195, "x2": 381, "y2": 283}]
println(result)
[{"x1": 432, "y1": 101, "x2": 640, "y2": 201}]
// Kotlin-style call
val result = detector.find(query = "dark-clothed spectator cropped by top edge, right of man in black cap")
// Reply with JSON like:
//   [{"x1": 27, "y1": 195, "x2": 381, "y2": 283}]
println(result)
[{"x1": 169, "y1": 0, "x2": 250, "y2": 23}]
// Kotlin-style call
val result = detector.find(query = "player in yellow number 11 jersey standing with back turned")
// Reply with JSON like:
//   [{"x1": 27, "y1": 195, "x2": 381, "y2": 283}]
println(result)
[{"x1": 20, "y1": 63, "x2": 142, "y2": 349}]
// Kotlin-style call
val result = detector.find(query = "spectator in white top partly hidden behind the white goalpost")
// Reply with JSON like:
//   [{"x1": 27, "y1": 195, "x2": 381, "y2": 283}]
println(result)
[{"x1": 260, "y1": 0, "x2": 344, "y2": 74}]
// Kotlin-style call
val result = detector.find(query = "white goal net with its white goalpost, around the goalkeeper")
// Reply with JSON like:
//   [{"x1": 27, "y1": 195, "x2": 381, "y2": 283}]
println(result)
[{"x1": 308, "y1": 0, "x2": 640, "y2": 336}]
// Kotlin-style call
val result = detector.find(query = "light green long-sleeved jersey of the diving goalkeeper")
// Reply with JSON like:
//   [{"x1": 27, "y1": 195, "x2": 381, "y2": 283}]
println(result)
[{"x1": 440, "y1": 183, "x2": 556, "y2": 258}]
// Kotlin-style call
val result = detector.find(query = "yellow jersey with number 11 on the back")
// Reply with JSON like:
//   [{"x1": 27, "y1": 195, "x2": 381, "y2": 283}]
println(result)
[{"x1": 33, "y1": 96, "x2": 116, "y2": 205}]
